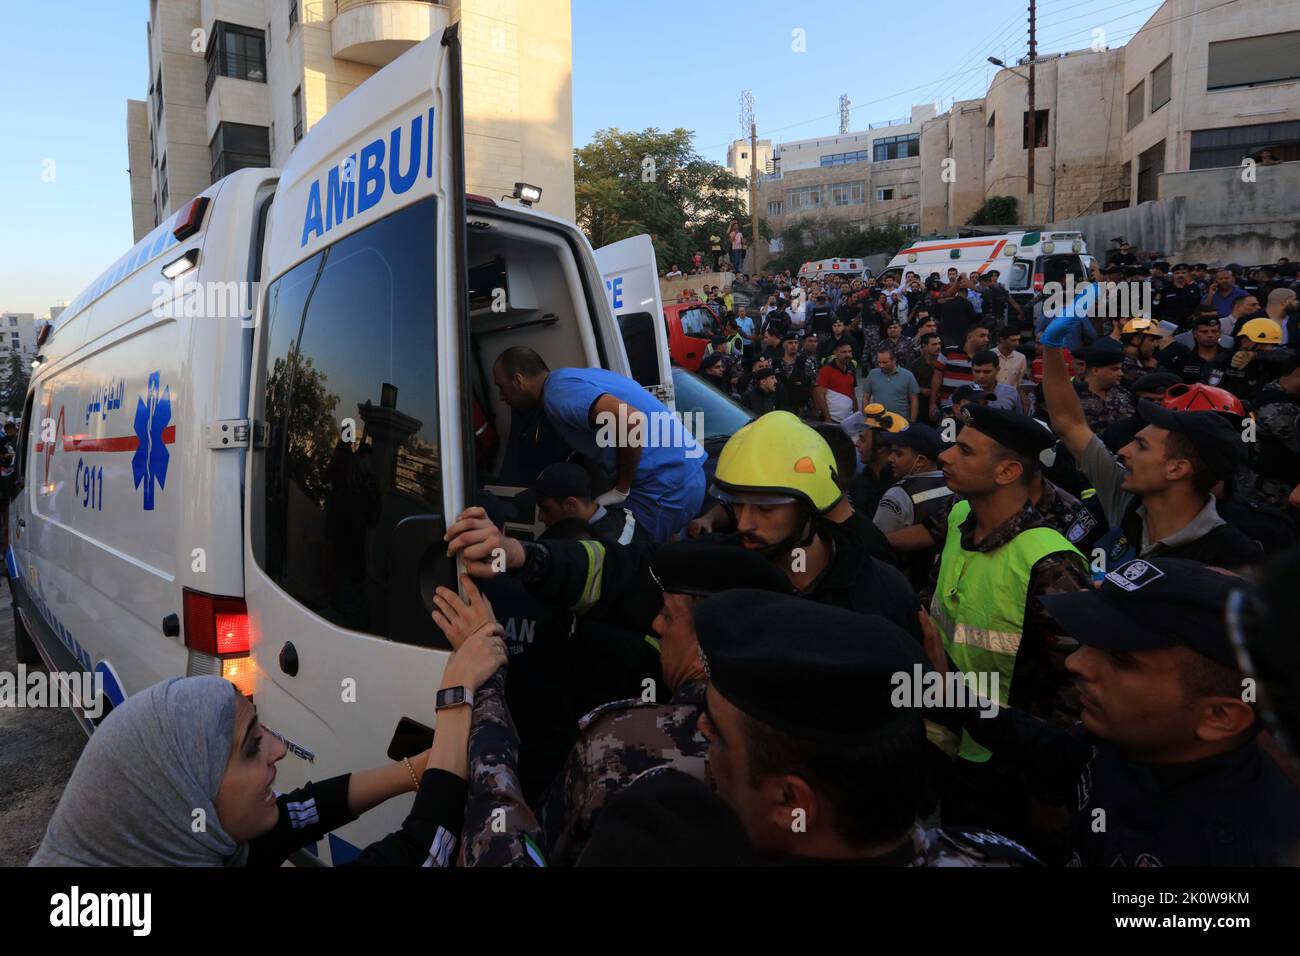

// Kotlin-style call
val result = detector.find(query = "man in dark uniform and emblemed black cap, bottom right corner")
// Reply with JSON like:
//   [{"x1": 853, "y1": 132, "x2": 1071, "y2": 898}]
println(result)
[{"x1": 966, "y1": 557, "x2": 1300, "y2": 866}]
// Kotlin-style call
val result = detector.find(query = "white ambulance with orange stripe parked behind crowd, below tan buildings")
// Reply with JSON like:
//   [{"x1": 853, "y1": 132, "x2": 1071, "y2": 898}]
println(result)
[{"x1": 880, "y1": 230, "x2": 1089, "y2": 306}]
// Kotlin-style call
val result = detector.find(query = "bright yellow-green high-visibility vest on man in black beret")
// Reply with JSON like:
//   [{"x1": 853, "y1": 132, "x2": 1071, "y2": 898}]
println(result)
[{"x1": 930, "y1": 501, "x2": 1088, "y2": 762}]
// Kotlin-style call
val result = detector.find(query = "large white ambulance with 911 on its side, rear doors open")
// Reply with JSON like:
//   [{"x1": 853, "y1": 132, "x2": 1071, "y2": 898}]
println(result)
[{"x1": 7, "y1": 27, "x2": 672, "y2": 862}]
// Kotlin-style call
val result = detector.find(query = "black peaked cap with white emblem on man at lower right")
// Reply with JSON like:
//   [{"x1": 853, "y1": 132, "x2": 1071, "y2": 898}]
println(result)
[{"x1": 1039, "y1": 558, "x2": 1242, "y2": 669}]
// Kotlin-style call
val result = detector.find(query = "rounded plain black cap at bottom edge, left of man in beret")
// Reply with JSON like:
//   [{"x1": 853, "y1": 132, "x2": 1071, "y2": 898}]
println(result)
[{"x1": 577, "y1": 766, "x2": 759, "y2": 866}]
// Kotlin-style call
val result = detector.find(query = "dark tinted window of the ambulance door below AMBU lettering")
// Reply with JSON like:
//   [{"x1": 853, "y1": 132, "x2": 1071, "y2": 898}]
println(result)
[{"x1": 254, "y1": 199, "x2": 445, "y2": 646}]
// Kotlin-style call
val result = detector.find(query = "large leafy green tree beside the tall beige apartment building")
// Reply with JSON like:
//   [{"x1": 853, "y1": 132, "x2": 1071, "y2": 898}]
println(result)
[{"x1": 573, "y1": 129, "x2": 762, "y2": 272}]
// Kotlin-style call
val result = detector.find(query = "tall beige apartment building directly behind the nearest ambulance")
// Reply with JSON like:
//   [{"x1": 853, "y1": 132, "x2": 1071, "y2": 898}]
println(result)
[{"x1": 127, "y1": 0, "x2": 573, "y2": 239}]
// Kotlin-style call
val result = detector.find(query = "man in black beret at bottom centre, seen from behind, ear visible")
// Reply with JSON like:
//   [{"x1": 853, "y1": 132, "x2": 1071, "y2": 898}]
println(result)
[{"x1": 696, "y1": 591, "x2": 1037, "y2": 866}]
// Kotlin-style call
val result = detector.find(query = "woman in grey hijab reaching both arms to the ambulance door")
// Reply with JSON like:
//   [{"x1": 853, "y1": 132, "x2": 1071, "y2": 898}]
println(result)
[{"x1": 31, "y1": 620, "x2": 506, "y2": 866}]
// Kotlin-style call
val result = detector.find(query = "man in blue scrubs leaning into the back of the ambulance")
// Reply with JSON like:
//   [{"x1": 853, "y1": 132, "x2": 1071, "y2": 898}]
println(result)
[{"x1": 493, "y1": 346, "x2": 706, "y2": 542}]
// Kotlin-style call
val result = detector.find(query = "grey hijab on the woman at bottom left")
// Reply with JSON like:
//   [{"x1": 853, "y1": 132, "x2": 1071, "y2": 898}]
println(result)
[{"x1": 31, "y1": 676, "x2": 247, "y2": 866}]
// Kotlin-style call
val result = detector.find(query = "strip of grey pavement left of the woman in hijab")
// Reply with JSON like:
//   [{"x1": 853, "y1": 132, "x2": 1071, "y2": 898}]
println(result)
[{"x1": 0, "y1": 579, "x2": 86, "y2": 866}]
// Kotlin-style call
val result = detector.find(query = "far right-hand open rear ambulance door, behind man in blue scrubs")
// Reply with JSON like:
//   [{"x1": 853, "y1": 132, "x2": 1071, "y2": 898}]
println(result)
[{"x1": 595, "y1": 235, "x2": 673, "y2": 408}]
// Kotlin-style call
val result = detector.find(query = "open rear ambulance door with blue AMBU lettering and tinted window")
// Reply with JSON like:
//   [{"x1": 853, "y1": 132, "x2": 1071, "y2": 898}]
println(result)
[{"x1": 244, "y1": 26, "x2": 473, "y2": 864}]
